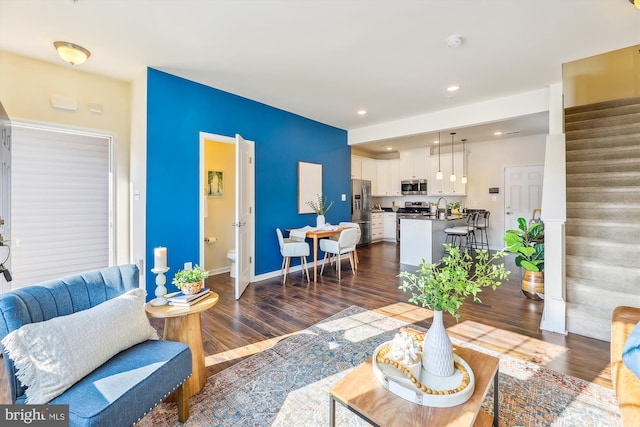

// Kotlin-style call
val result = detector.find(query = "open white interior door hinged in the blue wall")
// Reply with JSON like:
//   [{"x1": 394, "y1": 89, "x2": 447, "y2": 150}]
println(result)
[{"x1": 234, "y1": 135, "x2": 253, "y2": 299}]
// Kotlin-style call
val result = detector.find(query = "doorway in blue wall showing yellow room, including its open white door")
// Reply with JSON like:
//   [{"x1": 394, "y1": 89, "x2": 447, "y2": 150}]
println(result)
[{"x1": 200, "y1": 132, "x2": 255, "y2": 299}]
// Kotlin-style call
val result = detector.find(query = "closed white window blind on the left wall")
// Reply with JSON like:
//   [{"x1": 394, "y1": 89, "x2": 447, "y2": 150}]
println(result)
[{"x1": 11, "y1": 126, "x2": 111, "y2": 289}]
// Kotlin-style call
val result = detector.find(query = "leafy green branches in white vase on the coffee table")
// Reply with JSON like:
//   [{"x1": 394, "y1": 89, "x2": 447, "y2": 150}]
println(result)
[{"x1": 398, "y1": 244, "x2": 510, "y2": 377}]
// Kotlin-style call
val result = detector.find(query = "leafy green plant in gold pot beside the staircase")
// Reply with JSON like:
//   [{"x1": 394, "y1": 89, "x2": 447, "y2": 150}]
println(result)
[{"x1": 504, "y1": 218, "x2": 544, "y2": 300}]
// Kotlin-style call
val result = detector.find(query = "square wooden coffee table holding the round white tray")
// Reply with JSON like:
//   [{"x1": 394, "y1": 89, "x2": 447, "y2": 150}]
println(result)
[{"x1": 329, "y1": 347, "x2": 500, "y2": 427}]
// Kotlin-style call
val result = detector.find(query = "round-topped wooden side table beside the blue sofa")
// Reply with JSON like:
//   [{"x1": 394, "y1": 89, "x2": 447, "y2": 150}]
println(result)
[{"x1": 145, "y1": 292, "x2": 218, "y2": 398}]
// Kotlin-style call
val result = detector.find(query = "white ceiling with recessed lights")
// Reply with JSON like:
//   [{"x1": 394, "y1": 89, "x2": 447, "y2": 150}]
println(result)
[{"x1": 0, "y1": 0, "x2": 640, "y2": 151}]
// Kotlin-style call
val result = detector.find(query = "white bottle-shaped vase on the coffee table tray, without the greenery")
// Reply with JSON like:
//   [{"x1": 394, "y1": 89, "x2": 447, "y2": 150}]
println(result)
[{"x1": 422, "y1": 311, "x2": 454, "y2": 377}]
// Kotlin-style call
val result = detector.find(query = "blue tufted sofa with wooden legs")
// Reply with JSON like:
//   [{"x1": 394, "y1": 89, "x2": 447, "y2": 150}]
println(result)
[{"x1": 0, "y1": 265, "x2": 192, "y2": 427}]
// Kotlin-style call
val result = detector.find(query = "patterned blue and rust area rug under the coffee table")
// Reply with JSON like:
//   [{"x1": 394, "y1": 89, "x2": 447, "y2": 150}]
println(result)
[{"x1": 138, "y1": 306, "x2": 622, "y2": 427}]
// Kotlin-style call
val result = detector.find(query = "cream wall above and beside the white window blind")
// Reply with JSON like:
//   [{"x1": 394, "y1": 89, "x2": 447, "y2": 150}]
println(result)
[{"x1": 0, "y1": 51, "x2": 131, "y2": 264}]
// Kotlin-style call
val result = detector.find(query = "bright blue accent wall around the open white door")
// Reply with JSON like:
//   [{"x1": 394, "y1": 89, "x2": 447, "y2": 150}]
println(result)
[{"x1": 146, "y1": 68, "x2": 351, "y2": 297}]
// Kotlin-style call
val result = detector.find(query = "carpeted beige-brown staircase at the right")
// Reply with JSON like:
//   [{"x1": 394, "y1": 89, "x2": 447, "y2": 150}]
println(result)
[{"x1": 565, "y1": 98, "x2": 640, "y2": 341}]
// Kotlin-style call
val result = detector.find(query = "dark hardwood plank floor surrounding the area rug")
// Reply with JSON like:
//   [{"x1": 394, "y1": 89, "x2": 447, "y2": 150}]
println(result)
[{"x1": 0, "y1": 242, "x2": 611, "y2": 403}]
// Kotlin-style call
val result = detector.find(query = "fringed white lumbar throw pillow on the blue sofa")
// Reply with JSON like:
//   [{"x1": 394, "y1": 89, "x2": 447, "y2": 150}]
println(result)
[{"x1": 2, "y1": 288, "x2": 158, "y2": 404}]
